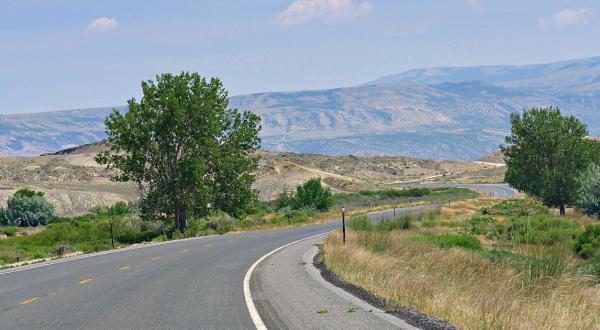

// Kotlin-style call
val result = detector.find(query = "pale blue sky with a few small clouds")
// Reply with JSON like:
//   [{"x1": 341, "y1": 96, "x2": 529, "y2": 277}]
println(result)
[{"x1": 0, "y1": 0, "x2": 600, "y2": 114}]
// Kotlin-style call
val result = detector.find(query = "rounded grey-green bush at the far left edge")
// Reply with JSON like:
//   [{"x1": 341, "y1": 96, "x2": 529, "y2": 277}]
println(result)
[{"x1": 3, "y1": 189, "x2": 54, "y2": 227}]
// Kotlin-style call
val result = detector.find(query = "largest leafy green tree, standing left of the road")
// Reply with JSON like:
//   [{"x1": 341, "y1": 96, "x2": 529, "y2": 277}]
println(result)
[{"x1": 96, "y1": 72, "x2": 261, "y2": 230}]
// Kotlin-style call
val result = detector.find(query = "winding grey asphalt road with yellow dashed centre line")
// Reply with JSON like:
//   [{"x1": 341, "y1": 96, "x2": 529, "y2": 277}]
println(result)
[{"x1": 0, "y1": 185, "x2": 514, "y2": 329}]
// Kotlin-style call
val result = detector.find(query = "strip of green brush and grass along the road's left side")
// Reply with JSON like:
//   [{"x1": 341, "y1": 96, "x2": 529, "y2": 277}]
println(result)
[{"x1": 0, "y1": 188, "x2": 477, "y2": 267}]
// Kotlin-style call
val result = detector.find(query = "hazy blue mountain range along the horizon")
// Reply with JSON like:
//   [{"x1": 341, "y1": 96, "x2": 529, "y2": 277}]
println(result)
[{"x1": 0, "y1": 57, "x2": 600, "y2": 160}]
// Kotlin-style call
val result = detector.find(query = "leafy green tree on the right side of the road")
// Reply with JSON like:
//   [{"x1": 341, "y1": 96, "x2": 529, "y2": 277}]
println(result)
[{"x1": 501, "y1": 107, "x2": 597, "y2": 215}]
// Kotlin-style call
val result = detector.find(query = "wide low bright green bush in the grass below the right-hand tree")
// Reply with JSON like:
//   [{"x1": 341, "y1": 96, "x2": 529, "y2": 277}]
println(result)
[{"x1": 507, "y1": 215, "x2": 582, "y2": 245}]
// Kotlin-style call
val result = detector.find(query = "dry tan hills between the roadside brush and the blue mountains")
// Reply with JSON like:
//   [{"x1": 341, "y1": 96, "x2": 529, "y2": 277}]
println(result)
[{"x1": 0, "y1": 143, "x2": 503, "y2": 216}]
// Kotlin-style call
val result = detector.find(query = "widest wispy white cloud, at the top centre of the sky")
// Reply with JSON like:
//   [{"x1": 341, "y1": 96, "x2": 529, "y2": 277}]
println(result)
[{"x1": 278, "y1": 0, "x2": 373, "y2": 26}]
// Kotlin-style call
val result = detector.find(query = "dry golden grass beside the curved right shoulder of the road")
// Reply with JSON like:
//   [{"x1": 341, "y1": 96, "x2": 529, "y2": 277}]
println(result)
[{"x1": 323, "y1": 232, "x2": 600, "y2": 329}]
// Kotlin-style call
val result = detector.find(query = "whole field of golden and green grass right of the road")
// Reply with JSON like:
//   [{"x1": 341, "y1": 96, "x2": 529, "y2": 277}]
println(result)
[{"x1": 323, "y1": 198, "x2": 600, "y2": 329}]
